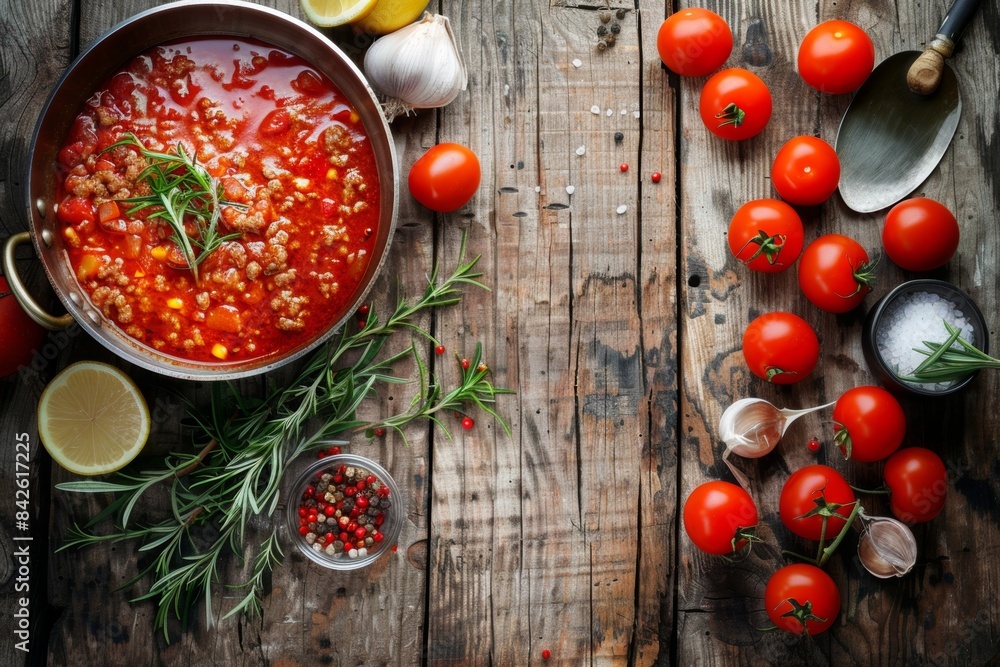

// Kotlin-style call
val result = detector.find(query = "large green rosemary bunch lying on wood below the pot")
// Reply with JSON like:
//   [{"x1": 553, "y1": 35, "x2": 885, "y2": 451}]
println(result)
[{"x1": 57, "y1": 240, "x2": 512, "y2": 641}]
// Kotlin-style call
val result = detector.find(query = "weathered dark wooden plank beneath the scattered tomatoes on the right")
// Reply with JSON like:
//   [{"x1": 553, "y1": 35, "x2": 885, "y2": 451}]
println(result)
[{"x1": 677, "y1": 2, "x2": 1000, "y2": 664}]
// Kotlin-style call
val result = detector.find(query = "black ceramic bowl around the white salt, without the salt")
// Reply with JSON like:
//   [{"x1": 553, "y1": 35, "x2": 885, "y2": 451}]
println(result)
[{"x1": 861, "y1": 279, "x2": 990, "y2": 396}]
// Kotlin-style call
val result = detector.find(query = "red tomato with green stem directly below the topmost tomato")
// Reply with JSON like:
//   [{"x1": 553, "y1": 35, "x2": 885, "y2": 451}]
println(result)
[{"x1": 699, "y1": 67, "x2": 771, "y2": 141}]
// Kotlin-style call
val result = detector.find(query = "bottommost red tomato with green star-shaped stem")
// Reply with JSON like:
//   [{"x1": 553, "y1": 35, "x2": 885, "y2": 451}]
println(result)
[{"x1": 764, "y1": 563, "x2": 840, "y2": 635}]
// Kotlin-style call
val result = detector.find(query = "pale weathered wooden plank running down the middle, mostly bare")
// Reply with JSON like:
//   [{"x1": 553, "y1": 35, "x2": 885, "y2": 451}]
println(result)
[{"x1": 428, "y1": 3, "x2": 673, "y2": 664}]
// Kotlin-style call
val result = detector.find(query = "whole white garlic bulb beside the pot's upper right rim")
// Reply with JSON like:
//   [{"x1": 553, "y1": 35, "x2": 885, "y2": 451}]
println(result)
[{"x1": 365, "y1": 12, "x2": 468, "y2": 121}]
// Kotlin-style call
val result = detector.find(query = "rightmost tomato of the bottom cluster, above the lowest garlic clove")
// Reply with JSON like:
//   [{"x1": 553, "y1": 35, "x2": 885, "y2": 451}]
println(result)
[{"x1": 882, "y1": 447, "x2": 948, "y2": 523}]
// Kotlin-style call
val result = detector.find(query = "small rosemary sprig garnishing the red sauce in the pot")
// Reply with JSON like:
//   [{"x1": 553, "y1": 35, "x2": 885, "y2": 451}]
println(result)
[{"x1": 103, "y1": 133, "x2": 244, "y2": 282}]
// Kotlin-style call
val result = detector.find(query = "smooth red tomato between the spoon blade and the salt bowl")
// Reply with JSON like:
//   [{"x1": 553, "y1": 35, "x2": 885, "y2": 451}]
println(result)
[{"x1": 882, "y1": 197, "x2": 959, "y2": 271}]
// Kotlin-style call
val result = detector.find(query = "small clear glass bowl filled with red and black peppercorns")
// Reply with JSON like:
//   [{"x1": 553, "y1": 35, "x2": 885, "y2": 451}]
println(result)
[{"x1": 287, "y1": 454, "x2": 403, "y2": 570}]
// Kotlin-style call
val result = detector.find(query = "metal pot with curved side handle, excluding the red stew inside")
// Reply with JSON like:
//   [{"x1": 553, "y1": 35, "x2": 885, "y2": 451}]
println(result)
[{"x1": 3, "y1": 0, "x2": 399, "y2": 380}]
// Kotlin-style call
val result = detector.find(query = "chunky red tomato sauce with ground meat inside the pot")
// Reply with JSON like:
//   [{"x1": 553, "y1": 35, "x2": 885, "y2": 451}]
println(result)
[{"x1": 57, "y1": 38, "x2": 379, "y2": 361}]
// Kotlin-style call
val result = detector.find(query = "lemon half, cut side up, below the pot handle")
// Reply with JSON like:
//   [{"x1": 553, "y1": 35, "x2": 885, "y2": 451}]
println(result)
[{"x1": 38, "y1": 361, "x2": 149, "y2": 475}]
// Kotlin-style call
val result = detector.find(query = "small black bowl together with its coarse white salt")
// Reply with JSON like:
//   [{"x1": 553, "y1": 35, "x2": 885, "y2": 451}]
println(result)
[{"x1": 861, "y1": 279, "x2": 989, "y2": 396}]
